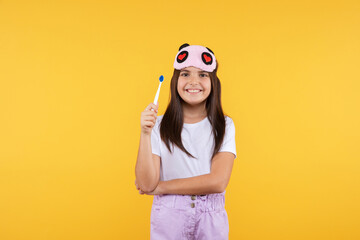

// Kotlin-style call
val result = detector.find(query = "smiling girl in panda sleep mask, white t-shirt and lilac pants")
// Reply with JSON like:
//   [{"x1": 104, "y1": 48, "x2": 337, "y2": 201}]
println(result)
[{"x1": 135, "y1": 44, "x2": 236, "y2": 240}]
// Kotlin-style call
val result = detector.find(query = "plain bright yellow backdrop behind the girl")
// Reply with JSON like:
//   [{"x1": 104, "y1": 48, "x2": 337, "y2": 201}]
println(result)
[{"x1": 0, "y1": 0, "x2": 360, "y2": 240}]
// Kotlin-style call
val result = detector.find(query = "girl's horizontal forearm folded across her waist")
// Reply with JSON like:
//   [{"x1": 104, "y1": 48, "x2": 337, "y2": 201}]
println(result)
[{"x1": 159, "y1": 173, "x2": 224, "y2": 195}]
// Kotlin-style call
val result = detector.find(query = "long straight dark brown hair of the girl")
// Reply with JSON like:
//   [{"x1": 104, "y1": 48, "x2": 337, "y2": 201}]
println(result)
[{"x1": 160, "y1": 62, "x2": 226, "y2": 158}]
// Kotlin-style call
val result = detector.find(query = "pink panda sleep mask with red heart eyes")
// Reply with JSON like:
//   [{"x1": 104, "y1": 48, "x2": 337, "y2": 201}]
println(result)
[{"x1": 174, "y1": 43, "x2": 216, "y2": 72}]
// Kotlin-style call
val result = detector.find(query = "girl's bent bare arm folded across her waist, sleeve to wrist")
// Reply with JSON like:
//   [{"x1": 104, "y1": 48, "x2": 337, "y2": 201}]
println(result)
[{"x1": 158, "y1": 152, "x2": 235, "y2": 195}]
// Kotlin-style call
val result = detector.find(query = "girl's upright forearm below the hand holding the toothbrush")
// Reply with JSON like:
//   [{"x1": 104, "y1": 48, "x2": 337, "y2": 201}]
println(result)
[{"x1": 135, "y1": 133, "x2": 159, "y2": 191}]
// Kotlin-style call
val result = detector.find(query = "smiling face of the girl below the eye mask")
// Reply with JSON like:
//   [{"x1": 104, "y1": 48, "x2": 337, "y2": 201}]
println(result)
[{"x1": 177, "y1": 67, "x2": 211, "y2": 105}]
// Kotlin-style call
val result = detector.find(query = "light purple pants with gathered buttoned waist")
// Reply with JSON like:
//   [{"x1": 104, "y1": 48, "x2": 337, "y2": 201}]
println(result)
[{"x1": 150, "y1": 192, "x2": 229, "y2": 240}]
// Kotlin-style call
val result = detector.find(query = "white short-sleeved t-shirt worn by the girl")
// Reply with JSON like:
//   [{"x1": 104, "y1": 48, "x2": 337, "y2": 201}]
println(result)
[{"x1": 151, "y1": 115, "x2": 236, "y2": 181}]
